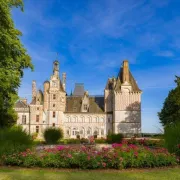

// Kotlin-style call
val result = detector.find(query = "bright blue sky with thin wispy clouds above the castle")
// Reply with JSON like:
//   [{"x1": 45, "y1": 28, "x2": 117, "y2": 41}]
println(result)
[{"x1": 12, "y1": 0, "x2": 180, "y2": 132}]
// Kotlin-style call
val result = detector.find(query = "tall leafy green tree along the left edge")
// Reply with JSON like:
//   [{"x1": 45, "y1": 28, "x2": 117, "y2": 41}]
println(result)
[{"x1": 0, "y1": 0, "x2": 33, "y2": 127}]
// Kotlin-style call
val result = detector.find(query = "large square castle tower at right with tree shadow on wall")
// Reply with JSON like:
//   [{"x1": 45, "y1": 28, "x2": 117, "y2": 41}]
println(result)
[{"x1": 113, "y1": 60, "x2": 142, "y2": 134}]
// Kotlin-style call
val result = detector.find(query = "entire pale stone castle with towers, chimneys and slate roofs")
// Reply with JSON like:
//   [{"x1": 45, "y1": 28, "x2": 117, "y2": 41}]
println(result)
[{"x1": 15, "y1": 60, "x2": 142, "y2": 138}]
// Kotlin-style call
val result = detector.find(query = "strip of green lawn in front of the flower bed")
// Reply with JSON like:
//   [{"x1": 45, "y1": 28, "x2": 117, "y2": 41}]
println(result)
[{"x1": 0, "y1": 167, "x2": 180, "y2": 180}]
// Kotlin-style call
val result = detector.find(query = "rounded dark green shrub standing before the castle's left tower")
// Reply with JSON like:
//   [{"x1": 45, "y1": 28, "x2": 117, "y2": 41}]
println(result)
[{"x1": 43, "y1": 127, "x2": 63, "y2": 144}]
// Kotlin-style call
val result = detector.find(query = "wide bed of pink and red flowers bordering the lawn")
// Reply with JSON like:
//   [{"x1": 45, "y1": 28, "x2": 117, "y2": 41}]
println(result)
[{"x1": 2, "y1": 144, "x2": 177, "y2": 169}]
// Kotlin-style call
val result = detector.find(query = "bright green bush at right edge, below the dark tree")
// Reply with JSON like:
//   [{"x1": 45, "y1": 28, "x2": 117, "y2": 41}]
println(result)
[{"x1": 164, "y1": 122, "x2": 180, "y2": 156}]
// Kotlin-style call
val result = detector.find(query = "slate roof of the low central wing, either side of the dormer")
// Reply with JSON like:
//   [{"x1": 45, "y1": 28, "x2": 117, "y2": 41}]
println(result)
[{"x1": 66, "y1": 96, "x2": 104, "y2": 113}]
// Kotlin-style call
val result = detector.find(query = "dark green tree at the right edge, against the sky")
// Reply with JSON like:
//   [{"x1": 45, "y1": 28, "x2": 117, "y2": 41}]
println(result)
[{"x1": 158, "y1": 76, "x2": 180, "y2": 126}]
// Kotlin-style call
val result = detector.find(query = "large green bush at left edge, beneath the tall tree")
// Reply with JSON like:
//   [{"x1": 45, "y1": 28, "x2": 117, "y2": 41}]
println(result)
[{"x1": 0, "y1": 126, "x2": 33, "y2": 156}]
